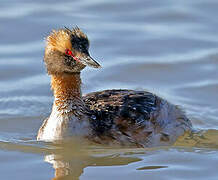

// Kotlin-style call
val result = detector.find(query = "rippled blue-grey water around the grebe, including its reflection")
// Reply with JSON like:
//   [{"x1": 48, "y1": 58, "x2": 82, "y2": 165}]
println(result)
[{"x1": 0, "y1": 0, "x2": 218, "y2": 180}]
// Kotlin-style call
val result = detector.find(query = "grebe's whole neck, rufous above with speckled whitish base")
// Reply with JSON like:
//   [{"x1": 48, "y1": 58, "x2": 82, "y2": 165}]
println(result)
[{"x1": 51, "y1": 73, "x2": 83, "y2": 114}]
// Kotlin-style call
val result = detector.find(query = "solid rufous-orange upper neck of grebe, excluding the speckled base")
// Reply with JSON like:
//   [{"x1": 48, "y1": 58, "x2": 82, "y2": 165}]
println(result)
[{"x1": 51, "y1": 73, "x2": 81, "y2": 100}]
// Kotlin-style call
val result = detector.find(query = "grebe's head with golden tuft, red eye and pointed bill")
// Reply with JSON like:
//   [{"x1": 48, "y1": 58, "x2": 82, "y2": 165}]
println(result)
[{"x1": 44, "y1": 27, "x2": 101, "y2": 74}]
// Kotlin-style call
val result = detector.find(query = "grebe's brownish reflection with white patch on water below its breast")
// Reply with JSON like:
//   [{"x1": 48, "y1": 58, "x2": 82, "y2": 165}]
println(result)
[{"x1": 45, "y1": 139, "x2": 141, "y2": 180}]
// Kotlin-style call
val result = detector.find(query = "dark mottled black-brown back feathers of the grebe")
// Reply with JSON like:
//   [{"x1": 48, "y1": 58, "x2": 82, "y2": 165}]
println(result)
[{"x1": 83, "y1": 90, "x2": 158, "y2": 137}]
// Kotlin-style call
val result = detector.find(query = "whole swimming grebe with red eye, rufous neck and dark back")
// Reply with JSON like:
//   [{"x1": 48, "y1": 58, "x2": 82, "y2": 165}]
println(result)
[{"x1": 37, "y1": 27, "x2": 192, "y2": 147}]
